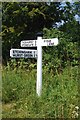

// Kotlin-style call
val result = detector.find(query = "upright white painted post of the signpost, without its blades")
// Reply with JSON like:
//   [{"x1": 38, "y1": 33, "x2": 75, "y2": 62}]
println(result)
[{"x1": 36, "y1": 37, "x2": 42, "y2": 96}]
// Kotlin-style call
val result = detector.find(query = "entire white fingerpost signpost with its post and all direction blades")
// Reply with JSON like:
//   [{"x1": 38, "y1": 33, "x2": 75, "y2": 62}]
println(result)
[{"x1": 10, "y1": 36, "x2": 58, "y2": 96}]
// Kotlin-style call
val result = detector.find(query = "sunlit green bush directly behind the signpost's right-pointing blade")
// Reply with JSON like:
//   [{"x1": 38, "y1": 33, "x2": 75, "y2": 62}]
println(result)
[{"x1": 43, "y1": 28, "x2": 79, "y2": 73}]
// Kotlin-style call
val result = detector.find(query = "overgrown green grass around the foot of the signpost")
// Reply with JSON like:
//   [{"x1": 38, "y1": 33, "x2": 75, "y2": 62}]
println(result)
[{"x1": 2, "y1": 66, "x2": 79, "y2": 118}]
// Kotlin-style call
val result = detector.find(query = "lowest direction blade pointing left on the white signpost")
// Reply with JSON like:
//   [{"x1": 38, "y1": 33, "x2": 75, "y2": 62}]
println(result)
[{"x1": 10, "y1": 49, "x2": 37, "y2": 58}]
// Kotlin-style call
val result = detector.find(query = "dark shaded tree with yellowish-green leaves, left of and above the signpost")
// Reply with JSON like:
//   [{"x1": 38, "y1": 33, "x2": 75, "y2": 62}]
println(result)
[{"x1": 2, "y1": 2, "x2": 58, "y2": 59}]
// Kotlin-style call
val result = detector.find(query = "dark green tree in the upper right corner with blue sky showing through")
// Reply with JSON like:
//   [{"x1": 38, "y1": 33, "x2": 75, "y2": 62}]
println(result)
[{"x1": 59, "y1": 2, "x2": 80, "y2": 42}]
